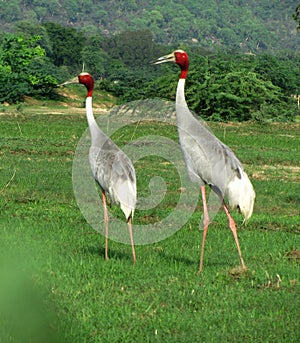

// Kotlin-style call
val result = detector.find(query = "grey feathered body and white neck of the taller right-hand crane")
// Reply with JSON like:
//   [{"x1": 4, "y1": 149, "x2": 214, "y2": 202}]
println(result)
[{"x1": 176, "y1": 79, "x2": 255, "y2": 220}]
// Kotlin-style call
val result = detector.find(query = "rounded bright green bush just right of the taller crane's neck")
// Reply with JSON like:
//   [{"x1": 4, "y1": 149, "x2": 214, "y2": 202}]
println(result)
[{"x1": 190, "y1": 70, "x2": 290, "y2": 121}]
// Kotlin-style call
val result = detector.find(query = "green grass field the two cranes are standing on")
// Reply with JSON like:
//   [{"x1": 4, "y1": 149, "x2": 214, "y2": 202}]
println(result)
[{"x1": 0, "y1": 103, "x2": 300, "y2": 343}]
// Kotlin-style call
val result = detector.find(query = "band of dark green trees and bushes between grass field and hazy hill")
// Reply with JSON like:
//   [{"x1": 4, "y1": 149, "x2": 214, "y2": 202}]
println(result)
[{"x1": 1, "y1": 23, "x2": 300, "y2": 121}]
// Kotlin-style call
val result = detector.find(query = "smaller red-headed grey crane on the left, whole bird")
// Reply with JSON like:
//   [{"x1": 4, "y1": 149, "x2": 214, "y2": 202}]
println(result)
[{"x1": 64, "y1": 72, "x2": 137, "y2": 263}]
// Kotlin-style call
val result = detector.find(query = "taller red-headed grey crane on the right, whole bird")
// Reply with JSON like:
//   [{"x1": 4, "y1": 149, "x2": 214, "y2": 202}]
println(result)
[{"x1": 154, "y1": 50, "x2": 255, "y2": 272}]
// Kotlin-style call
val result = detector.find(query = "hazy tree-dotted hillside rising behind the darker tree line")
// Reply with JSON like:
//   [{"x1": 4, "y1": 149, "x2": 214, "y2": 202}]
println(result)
[{"x1": 0, "y1": 0, "x2": 300, "y2": 53}]
